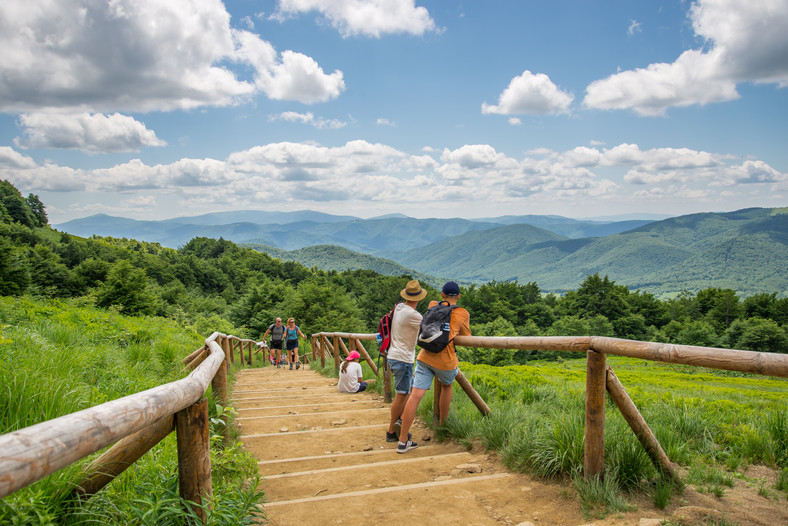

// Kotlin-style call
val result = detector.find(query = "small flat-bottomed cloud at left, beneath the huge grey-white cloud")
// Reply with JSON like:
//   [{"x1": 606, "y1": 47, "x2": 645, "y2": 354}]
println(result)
[{"x1": 14, "y1": 113, "x2": 167, "y2": 153}]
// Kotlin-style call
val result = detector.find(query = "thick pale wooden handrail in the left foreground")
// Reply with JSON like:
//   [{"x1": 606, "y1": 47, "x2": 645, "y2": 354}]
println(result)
[{"x1": 0, "y1": 340, "x2": 225, "y2": 498}]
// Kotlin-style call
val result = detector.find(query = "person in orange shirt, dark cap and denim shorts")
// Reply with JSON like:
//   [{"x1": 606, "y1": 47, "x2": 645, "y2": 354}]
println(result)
[{"x1": 397, "y1": 281, "x2": 471, "y2": 453}]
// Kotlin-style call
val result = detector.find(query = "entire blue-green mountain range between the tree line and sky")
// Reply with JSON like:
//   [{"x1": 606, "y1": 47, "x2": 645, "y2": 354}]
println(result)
[{"x1": 55, "y1": 208, "x2": 788, "y2": 297}]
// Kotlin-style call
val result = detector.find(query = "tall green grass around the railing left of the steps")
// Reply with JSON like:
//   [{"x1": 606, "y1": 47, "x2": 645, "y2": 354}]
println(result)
[{"x1": 0, "y1": 297, "x2": 262, "y2": 525}]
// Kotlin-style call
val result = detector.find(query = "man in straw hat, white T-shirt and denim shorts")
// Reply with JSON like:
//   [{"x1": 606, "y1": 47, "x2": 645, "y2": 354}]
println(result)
[{"x1": 386, "y1": 279, "x2": 427, "y2": 442}]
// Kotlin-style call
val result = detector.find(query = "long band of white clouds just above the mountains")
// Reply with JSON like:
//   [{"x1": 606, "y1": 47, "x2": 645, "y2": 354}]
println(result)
[{"x1": 0, "y1": 140, "x2": 788, "y2": 219}]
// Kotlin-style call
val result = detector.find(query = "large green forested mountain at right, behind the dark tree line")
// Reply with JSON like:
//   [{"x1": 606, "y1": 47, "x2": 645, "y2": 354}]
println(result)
[{"x1": 391, "y1": 208, "x2": 788, "y2": 296}]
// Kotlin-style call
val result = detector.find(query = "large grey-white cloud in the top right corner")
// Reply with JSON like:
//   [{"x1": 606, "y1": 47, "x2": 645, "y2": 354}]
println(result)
[{"x1": 583, "y1": 0, "x2": 788, "y2": 116}]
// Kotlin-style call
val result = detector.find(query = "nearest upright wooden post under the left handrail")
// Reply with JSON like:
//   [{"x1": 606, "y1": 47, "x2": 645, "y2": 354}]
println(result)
[{"x1": 175, "y1": 398, "x2": 213, "y2": 522}]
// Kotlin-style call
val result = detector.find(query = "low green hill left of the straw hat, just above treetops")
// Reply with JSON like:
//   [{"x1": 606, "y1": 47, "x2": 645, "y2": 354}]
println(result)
[{"x1": 241, "y1": 243, "x2": 445, "y2": 287}]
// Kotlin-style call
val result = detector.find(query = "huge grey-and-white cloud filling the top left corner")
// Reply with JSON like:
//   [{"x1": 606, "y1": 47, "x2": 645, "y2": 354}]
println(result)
[{"x1": 0, "y1": 0, "x2": 344, "y2": 112}]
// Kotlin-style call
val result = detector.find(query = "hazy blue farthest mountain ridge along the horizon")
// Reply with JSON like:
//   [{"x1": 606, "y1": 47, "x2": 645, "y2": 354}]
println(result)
[{"x1": 54, "y1": 210, "x2": 650, "y2": 252}]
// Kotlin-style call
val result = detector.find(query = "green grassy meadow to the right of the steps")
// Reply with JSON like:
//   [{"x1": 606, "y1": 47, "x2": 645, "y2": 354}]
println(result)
[{"x1": 316, "y1": 346, "x2": 788, "y2": 517}]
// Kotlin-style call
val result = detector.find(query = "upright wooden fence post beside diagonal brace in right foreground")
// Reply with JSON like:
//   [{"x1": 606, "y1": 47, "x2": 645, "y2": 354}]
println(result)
[{"x1": 583, "y1": 349, "x2": 607, "y2": 480}]
